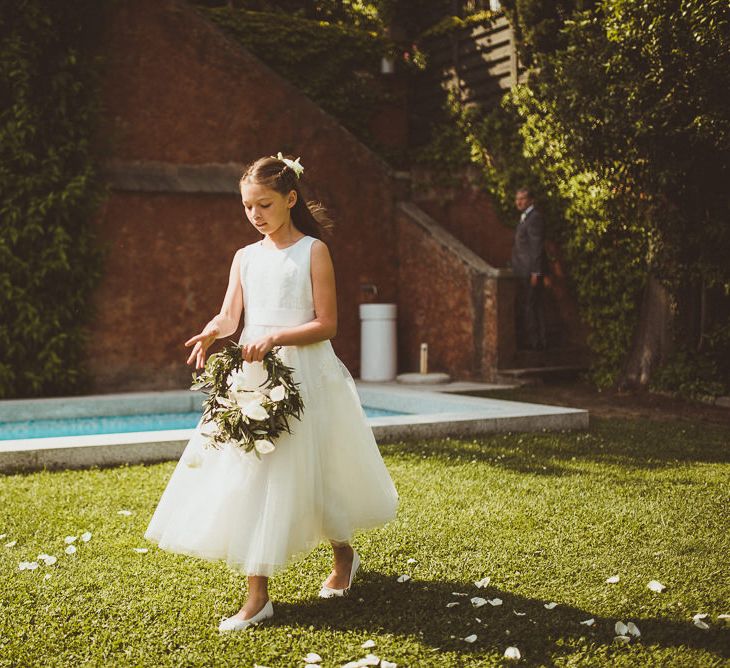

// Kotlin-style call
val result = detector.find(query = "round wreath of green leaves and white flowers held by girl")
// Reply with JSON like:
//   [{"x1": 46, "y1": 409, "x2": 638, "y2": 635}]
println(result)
[{"x1": 190, "y1": 342, "x2": 304, "y2": 459}]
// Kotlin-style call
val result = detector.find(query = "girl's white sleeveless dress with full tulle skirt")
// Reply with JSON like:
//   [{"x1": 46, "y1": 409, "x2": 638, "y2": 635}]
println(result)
[{"x1": 144, "y1": 236, "x2": 398, "y2": 576}]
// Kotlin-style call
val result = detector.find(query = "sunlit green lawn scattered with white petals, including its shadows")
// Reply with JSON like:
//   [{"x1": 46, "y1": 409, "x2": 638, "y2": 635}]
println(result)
[{"x1": 0, "y1": 419, "x2": 730, "y2": 668}]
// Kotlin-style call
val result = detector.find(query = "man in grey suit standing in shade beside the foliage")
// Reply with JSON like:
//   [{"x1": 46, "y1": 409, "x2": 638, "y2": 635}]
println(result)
[{"x1": 512, "y1": 188, "x2": 547, "y2": 350}]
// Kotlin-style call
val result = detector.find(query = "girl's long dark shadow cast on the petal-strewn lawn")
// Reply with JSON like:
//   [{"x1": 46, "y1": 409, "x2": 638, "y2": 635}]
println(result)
[{"x1": 258, "y1": 573, "x2": 730, "y2": 664}]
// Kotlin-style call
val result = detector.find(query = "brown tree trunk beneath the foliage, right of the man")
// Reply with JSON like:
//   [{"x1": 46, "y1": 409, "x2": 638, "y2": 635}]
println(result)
[{"x1": 619, "y1": 275, "x2": 673, "y2": 387}]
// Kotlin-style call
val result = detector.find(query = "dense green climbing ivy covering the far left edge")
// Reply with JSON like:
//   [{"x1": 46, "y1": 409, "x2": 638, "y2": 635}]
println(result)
[{"x1": 0, "y1": 0, "x2": 107, "y2": 397}]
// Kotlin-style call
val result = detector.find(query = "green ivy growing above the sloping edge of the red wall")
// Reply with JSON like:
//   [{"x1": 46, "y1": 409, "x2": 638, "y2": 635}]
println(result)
[{"x1": 201, "y1": 7, "x2": 393, "y2": 144}]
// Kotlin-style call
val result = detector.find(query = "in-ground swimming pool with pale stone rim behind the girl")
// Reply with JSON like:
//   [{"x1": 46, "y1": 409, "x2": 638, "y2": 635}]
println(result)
[{"x1": 0, "y1": 381, "x2": 588, "y2": 473}]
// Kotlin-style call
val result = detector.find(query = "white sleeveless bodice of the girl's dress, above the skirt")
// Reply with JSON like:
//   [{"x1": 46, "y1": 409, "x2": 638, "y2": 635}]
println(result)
[{"x1": 241, "y1": 236, "x2": 314, "y2": 327}]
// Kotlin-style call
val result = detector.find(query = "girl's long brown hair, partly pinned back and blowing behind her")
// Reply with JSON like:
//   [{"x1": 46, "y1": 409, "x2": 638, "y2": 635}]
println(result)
[{"x1": 238, "y1": 158, "x2": 333, "y2": 239}]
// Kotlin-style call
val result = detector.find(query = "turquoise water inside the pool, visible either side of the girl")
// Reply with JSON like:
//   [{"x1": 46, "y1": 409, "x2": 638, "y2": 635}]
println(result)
[{"x1": 0, "y1": 406, "x2": 405, "y2": 441}]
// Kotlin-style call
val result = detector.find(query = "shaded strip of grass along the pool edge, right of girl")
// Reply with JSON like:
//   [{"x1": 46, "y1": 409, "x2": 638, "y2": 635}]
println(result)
[{"x1": 381, "y1": 418, "x2": 730, "y2": 476}]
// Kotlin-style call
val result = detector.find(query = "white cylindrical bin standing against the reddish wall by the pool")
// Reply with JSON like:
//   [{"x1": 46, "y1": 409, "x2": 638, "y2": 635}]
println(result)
[{"x1": 360, "y1": 304, "x2": 398, "y2": 381}]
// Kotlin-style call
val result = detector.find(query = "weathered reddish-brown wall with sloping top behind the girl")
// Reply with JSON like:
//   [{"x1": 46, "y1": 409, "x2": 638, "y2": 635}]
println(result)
[{"x1": 89, "y1": 0, "x2": 396, "y2": 392}]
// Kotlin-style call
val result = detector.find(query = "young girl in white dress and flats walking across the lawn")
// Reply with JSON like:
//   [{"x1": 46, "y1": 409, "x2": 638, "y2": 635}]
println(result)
[{"x1": 144, "y1": 154, "x2": 398, "y2": 631}]
